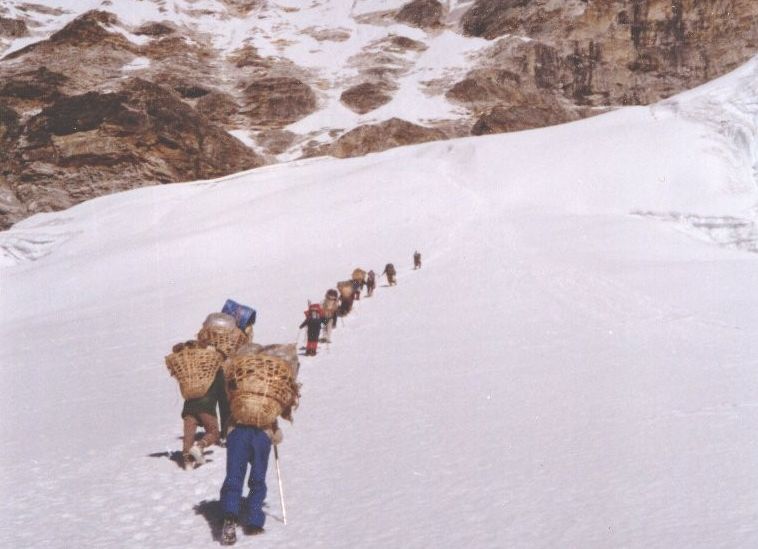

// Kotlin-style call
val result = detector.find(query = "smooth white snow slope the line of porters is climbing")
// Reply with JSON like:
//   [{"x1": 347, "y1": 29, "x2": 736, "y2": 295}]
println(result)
[{"x1": 0, "y1": 59, "x2": 758, "y2": 548}]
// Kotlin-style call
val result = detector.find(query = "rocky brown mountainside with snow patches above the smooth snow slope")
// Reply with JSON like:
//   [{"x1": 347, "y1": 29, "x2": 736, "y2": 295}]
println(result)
[{"x1": 0, "y1": 0, "x2": 758, "y2": 228}]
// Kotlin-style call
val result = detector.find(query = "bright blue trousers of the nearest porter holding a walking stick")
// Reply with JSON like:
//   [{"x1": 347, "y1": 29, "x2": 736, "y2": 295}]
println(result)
[{"x1": 221, "y1": 426, "x2": 271, "y2": 528}]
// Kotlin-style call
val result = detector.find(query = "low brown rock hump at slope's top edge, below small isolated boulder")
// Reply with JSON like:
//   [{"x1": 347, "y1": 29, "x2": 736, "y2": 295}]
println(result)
[{"x1": 328, "y1": 118, "x2": 447, "y2": 158}]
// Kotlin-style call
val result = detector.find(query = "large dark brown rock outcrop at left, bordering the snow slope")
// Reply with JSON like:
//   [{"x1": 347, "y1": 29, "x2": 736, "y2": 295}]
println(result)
[{"x1": 0, "y1": 79, "x2": 263, "y2": 227}]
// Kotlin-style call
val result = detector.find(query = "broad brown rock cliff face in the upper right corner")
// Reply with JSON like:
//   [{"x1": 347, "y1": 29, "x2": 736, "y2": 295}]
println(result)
[{"x1": 462, "y1": 0, "x2": 758, "y2": 106}]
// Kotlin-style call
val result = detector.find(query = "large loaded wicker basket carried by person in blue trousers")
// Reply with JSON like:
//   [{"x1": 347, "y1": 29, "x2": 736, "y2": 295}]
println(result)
[{"x1": 225, "y1": 345, "x2": 300, "y2": 429}]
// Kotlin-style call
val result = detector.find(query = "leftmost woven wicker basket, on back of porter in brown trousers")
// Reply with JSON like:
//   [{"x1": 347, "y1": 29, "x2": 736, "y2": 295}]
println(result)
[{"x1": 166, "y1": 341, "x2": 224, "y2": 400}]
